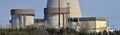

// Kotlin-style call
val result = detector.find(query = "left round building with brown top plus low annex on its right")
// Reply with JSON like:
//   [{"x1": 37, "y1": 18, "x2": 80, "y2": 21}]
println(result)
[{"x1": 9, "y1": 9, "x2": 45, "y2": 28}]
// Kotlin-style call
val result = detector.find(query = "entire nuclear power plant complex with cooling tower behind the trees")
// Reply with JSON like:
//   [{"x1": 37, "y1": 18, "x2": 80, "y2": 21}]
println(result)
[{"x1": 10, "y1": 0, "x2": 111, "y2": 32}]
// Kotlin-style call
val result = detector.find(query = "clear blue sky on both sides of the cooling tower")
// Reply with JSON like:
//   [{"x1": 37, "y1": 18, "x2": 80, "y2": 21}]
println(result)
[{"x1": 0, "y1": 0, "x2": 120, "y2": 29}]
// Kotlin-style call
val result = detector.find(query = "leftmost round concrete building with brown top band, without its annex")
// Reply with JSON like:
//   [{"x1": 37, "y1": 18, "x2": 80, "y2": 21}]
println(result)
[{"x1": 11, "y1": 9, "x2": 35, "y2": 28}]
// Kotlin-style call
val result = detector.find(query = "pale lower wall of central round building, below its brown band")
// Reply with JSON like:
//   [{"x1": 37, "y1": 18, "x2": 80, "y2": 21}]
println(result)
[{"x1": 46, "y1": 14, "x2": 63, "y2": 28}]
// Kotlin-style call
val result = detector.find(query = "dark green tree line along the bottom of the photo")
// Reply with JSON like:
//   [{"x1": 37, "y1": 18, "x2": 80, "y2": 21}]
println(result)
[{"x1": 0, "y1": 27, "x2": 120, "y2": 35}]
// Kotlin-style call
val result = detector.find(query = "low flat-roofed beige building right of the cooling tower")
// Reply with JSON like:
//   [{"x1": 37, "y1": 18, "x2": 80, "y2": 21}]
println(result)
[{"x1": 69, "y1": 17, "x2": 111, "y2": 32}]
